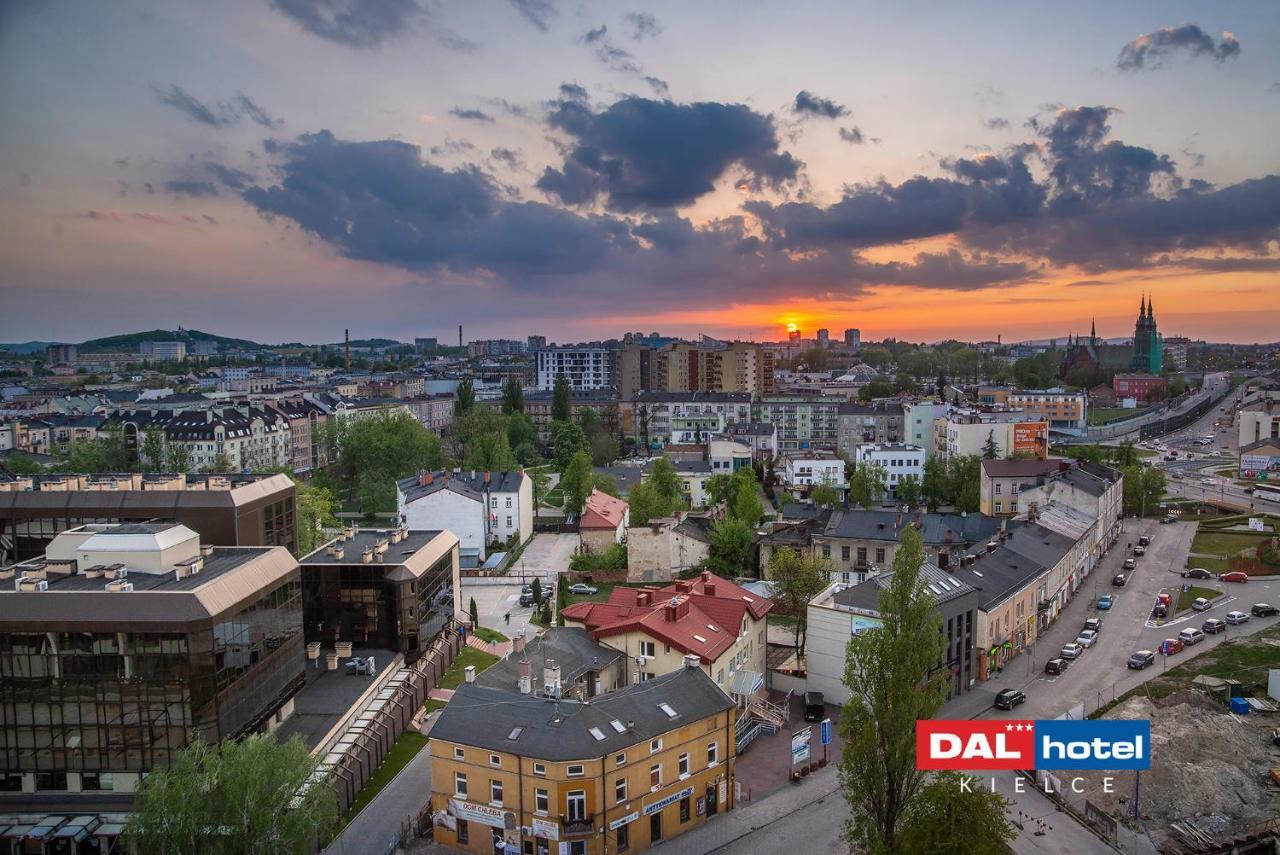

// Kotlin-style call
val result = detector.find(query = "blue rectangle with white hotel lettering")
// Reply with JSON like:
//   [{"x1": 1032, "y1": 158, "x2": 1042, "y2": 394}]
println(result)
[{"x1": 1036, "y1": 719, "x2": 1151, "y2": 771}]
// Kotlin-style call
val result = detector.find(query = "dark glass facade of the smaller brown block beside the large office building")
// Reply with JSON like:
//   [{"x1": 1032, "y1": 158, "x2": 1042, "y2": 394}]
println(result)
[{"x1": 302, "y1": 552, "x2": 453, "y2": 654}]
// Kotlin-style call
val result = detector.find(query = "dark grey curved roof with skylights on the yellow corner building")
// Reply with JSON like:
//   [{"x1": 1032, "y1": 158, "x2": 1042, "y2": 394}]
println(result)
[{"x1": 431, "y1": 667, "x2": 733, "y2": 762}]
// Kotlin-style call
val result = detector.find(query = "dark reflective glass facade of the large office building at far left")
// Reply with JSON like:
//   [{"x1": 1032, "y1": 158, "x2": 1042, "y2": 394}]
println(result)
[{"x1": 0, "y1": 575, "x2": 305, "y2": 788}]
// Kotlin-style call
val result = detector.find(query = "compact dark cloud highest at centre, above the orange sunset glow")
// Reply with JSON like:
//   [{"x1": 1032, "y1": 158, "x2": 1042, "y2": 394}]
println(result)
[{"x1": 538, "y1": 96, "x2": 801, "y2": 211}]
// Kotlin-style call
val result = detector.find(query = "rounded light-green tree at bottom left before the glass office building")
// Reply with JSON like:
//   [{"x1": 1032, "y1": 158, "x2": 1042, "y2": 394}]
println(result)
[{"x1": 124, "y1": 733, "x2": 338, "y2": 855}]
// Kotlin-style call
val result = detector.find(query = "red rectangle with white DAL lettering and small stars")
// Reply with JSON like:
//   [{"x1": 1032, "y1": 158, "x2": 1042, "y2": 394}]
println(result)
[{"x1": 915, "y1": 721, "x2": 1036, "y2": 771}]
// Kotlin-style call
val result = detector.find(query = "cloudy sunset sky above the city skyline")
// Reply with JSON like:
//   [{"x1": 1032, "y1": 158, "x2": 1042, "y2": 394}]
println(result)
[{"x1": 0, "y1": 0, "x2": 1280, "y2": 343}]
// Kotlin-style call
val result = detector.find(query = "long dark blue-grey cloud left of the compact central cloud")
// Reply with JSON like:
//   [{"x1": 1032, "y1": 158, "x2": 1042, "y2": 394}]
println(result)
[{"x1": 243, "y1": 131, "x2": 630, "y2": 276}]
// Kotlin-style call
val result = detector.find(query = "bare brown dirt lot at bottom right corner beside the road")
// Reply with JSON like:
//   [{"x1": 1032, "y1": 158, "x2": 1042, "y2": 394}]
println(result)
[{"x1": 1089, "y1": 690, "x2": 1280, "y2": 843}]
